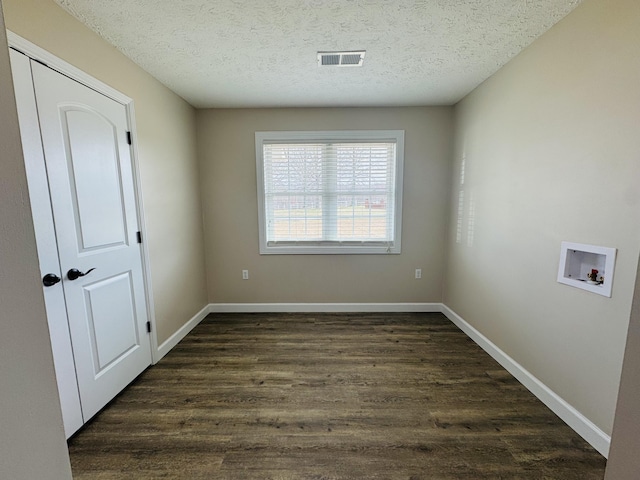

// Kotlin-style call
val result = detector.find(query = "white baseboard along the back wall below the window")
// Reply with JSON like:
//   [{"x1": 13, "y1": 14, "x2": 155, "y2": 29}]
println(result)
[{"x1": 209, "y1": 303, "x2": 442, "y2": 313}]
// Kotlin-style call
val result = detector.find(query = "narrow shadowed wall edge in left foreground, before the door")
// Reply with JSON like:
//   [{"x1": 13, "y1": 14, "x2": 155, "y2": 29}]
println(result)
[{"x1": 0, "y1": 2, "x2": 71, "y2": 479}]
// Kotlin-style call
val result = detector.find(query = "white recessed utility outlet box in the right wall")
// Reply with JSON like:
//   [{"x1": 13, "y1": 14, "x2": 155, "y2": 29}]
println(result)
[{"x1": 558, "y1": 242, "x2": 616, "y2": 297}]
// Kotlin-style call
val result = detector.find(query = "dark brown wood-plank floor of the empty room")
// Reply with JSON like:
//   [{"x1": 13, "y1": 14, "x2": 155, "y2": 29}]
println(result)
[{"x1": 69, "y1": 313, "x2": 605, "y2": 480}]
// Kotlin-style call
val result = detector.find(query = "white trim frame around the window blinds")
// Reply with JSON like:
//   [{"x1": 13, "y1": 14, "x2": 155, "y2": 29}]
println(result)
[{"x1": 255, "y1": 130, "x2": 404, "y2": 255}]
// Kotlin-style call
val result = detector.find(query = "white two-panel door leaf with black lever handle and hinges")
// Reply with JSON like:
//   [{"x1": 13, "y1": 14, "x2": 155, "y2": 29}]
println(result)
[{"x1": 13, "y1": 55, "x2": 151, "y2": 428}]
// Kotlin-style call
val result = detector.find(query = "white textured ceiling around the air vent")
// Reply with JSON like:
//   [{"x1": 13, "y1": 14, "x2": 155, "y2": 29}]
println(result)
[{"x1": 55, "y1": 0, "x2": 581, "y2": 107}]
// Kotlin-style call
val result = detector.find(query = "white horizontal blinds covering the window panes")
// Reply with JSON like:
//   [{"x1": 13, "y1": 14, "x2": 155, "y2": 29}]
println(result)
[{"x1": 262, "y1": 141, "x2": 397, "y2": 245}]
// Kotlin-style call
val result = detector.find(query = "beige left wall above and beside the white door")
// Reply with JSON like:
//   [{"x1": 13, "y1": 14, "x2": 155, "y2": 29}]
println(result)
[{"x1": 4, "y1": 0, "x2": 207, "y2": 343}]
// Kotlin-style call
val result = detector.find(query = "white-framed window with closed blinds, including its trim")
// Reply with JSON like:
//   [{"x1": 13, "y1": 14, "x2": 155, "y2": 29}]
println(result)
[{"x1": 256, "y1": 130, "x2": 404, "y2": 254}]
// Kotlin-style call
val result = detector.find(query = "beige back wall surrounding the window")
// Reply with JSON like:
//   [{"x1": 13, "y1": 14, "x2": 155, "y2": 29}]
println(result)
[{"x1": 198, "y1": 107, "x2": 451, "y2": 303}]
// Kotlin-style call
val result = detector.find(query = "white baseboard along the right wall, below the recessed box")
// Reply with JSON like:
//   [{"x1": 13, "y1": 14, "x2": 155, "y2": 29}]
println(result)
[{"x1": 442, "y1": 305, "x2": 611, "y2": 458}]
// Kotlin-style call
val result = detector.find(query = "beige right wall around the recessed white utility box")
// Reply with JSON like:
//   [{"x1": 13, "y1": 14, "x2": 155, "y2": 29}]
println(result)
[{"x1": 444, "y1": 0, "x2": 640, "y2": 434}]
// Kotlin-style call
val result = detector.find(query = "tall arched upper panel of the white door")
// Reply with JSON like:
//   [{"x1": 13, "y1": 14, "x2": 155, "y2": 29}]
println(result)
[{"x1": 60, "y1": 106, "x2": 126, "y2": 252}]
